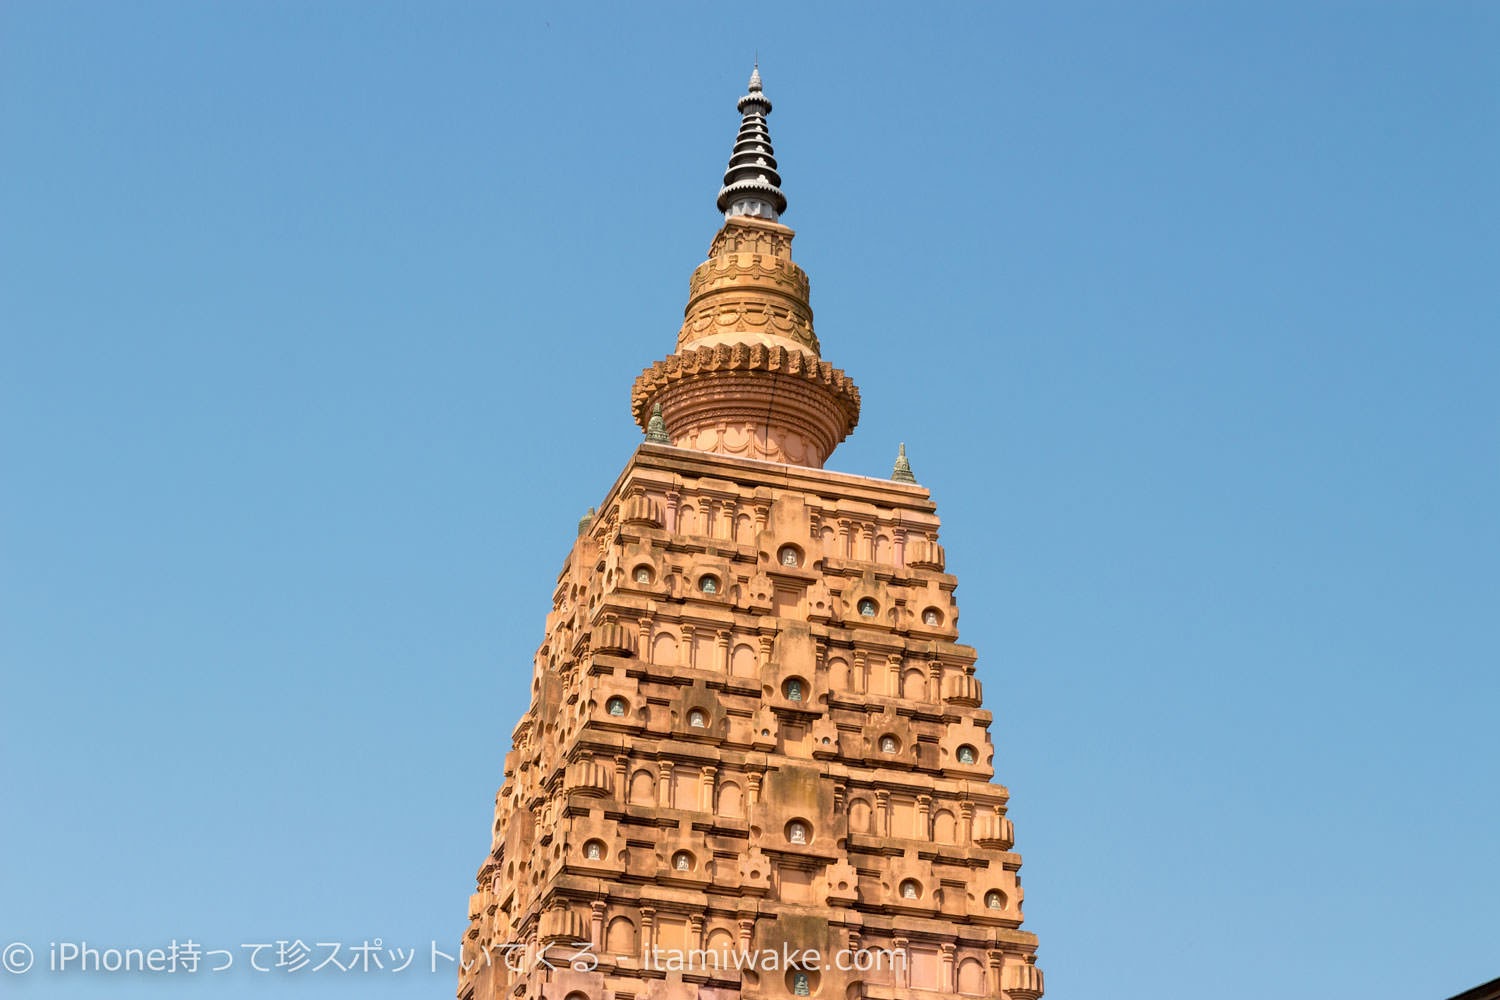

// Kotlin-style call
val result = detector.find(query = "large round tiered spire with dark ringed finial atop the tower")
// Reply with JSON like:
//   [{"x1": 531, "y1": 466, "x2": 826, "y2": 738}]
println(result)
[{"x1": 630, "y1": 67, "x2": 860, "y2": 468}]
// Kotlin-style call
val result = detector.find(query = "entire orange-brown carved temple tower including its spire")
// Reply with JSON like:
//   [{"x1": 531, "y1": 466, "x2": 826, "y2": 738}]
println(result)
[{"x1": 458, "y1": 70, "x2": 1043, "y2": 1000}]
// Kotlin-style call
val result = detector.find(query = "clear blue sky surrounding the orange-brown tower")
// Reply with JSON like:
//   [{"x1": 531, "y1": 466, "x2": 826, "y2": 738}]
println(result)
[{"x1": 0, "y1": 0, "x2": 1500, "y2": 1000}]
